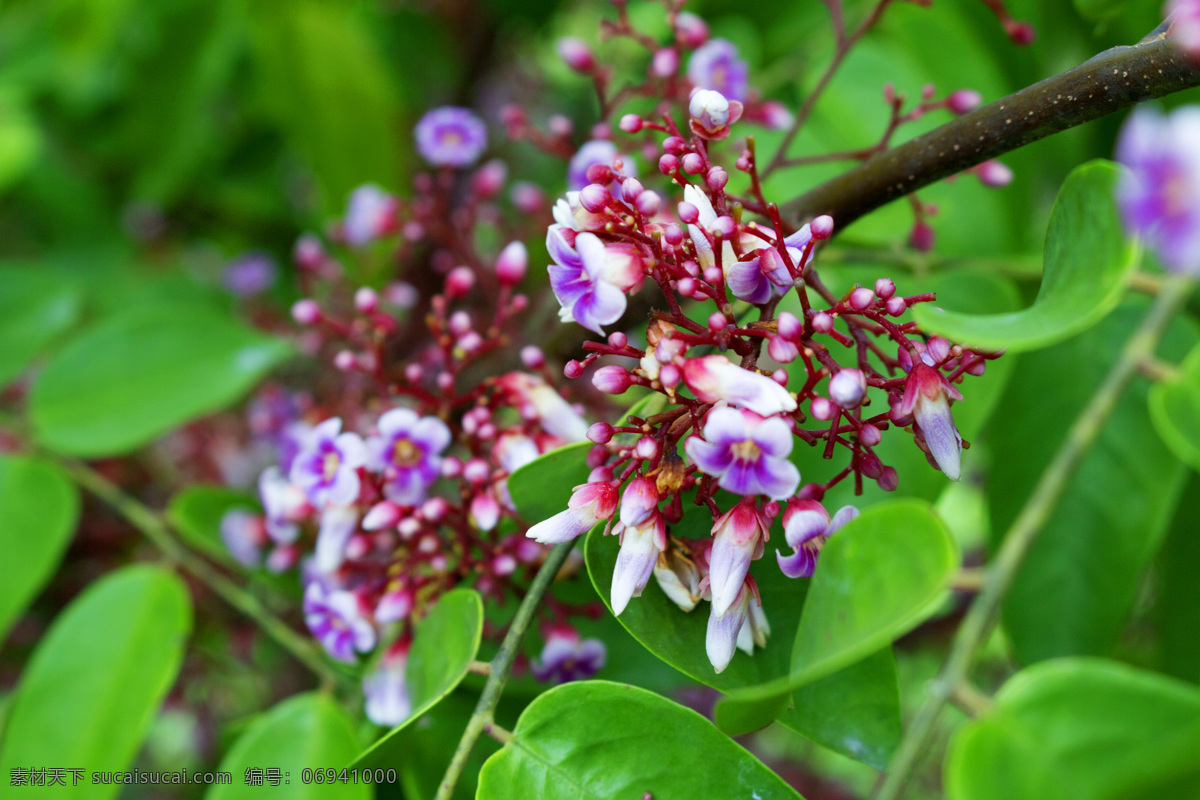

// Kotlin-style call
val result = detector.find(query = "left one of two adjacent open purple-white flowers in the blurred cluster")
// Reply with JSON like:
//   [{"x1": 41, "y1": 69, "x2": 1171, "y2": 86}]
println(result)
[{"x1": 288, "y1": 416, "x2": 366, "y2": 509}]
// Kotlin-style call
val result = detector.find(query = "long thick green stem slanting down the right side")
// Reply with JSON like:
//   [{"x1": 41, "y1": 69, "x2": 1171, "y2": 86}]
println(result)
[{"x1": 875, "y1": 276, "x2": 1195, "y2": 800}]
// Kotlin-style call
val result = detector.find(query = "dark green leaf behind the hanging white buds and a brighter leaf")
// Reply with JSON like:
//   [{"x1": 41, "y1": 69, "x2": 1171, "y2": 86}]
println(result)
[{"x1": 584, "y1": 507, "x2": 900, "y2": 768}]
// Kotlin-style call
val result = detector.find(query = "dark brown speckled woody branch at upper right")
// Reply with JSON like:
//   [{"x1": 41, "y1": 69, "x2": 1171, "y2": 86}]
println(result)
[{"x1": 782, "y1": 24, "x2": 1200, "y2": 230}]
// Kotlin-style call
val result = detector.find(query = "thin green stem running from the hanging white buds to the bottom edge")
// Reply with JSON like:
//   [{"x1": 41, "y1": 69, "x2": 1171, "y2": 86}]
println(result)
[{"x1": 434, "y1": 541, "x2": 575, "y2": 800}]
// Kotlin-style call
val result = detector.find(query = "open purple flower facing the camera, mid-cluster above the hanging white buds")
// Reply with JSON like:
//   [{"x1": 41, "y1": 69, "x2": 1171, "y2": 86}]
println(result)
[{"x1": 684, "y1": 408, "x2": 800, "y2": 500}]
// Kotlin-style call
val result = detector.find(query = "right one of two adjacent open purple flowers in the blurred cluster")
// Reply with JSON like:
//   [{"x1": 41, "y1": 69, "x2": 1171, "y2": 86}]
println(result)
[{"x1": 366, "y1": 408, "x2": 450, "y2": 506}]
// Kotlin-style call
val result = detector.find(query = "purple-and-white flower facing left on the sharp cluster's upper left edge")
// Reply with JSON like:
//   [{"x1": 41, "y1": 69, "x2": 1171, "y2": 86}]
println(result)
[{"x1": 546, "y1": 225, "x2": 646, "y2": 335}]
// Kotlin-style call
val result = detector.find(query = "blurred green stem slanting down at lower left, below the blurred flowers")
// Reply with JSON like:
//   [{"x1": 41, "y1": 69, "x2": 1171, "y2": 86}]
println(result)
[{"x1": 59, "y1": 458, "x2": 343, "y2": 686}]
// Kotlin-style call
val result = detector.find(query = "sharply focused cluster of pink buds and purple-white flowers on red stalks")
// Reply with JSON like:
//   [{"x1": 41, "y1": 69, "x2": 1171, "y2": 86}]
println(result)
[{"x1": 528, "y1": 1, "x2": 1010, "y2": 672}]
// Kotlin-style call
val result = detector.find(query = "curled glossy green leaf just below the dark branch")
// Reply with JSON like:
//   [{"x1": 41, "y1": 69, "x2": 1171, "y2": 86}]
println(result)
[{"x1": 913, "y1": 161, "x2": 1140, "y2": 353}]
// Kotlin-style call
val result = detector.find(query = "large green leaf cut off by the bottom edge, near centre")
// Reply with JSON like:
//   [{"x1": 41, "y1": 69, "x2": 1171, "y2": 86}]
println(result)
[{"x1": 476, "y1": 681, "x2": 799, "y2": 800}]
